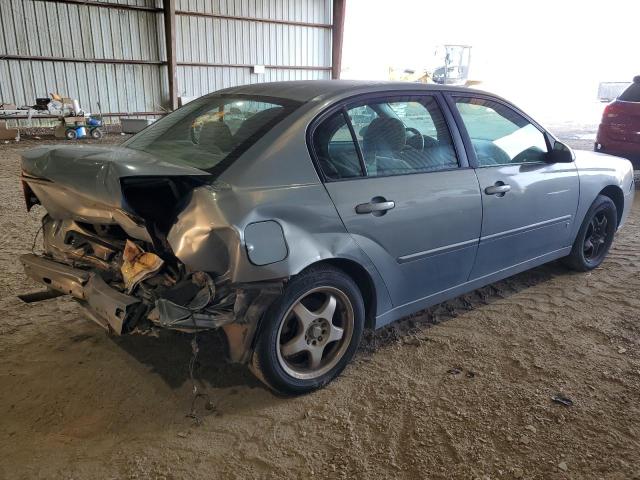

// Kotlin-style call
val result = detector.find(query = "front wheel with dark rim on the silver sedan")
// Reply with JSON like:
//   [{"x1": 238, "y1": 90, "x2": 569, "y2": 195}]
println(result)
[{"x1": 563, "y1": 195, "x2": 618, "y2": 272}]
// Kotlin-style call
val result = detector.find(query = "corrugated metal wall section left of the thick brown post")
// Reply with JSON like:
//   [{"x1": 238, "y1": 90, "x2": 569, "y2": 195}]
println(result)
[{"x1": 0, "y1": 0, "x2": 168, "y2": 120}]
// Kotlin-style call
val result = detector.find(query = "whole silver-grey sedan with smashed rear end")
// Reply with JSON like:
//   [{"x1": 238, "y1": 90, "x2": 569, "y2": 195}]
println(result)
[{"x1": 21, "y1": 81, "x2": 634, "y2": 394}]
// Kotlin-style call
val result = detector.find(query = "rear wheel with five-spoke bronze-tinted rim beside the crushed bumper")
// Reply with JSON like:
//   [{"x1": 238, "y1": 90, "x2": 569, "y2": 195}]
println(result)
[{"x1": 250, "y1": 266, "x2": 365, "y2": 395}]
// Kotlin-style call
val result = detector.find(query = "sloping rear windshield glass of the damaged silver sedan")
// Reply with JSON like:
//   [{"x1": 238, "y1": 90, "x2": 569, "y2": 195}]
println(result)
[{"x1": 123, "y1": 94, "x2": 300, "y2": 173}]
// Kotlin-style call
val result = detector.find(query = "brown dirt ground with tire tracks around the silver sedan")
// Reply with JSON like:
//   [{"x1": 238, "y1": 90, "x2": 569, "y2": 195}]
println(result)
[{"x1": 0, "y1": 134, "x2": 640, "y2": 479}]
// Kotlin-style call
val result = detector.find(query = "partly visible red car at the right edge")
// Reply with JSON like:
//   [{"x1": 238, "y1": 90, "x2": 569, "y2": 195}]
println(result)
[{"x1": 594, "y1": 75, "x2": 640, "y2": 170}]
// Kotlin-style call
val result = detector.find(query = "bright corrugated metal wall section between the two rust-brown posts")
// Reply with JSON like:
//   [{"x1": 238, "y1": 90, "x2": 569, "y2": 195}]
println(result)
[{"x1": 176, "y1": 0, "x2": 332, "y2": 97}]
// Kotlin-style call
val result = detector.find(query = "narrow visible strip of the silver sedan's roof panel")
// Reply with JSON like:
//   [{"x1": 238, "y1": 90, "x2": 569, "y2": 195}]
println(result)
[{"x1": 216, "y1": 80, "x2": 488, "y2": 102}]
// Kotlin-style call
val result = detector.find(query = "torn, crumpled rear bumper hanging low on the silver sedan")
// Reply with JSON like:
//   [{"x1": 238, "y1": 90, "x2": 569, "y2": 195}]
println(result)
[{"x1": 20, "y1": 254, "x2": 282, "y2": 363}]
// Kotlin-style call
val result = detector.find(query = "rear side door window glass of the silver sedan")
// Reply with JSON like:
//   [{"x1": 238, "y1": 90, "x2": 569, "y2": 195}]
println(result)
[{"x1": 313, "y1": 95, "x2": 459, "y2": 180}]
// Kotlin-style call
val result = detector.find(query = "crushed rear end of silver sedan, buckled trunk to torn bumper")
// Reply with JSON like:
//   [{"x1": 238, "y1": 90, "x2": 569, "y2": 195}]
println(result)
[{"x1": 20, "y1": 147, "x2": 280, "y2": 361}]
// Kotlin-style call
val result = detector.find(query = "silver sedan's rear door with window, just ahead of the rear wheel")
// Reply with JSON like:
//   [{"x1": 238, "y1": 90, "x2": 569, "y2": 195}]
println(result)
[{"x1": 312, "y1": 95, "x2": 482, "y2": 306}]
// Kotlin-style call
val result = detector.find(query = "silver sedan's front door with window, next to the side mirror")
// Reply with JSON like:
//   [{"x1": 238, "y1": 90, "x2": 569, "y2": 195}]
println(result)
[{"x1": 453, "y1": 96, "x2": 579, "y2": 279}]
